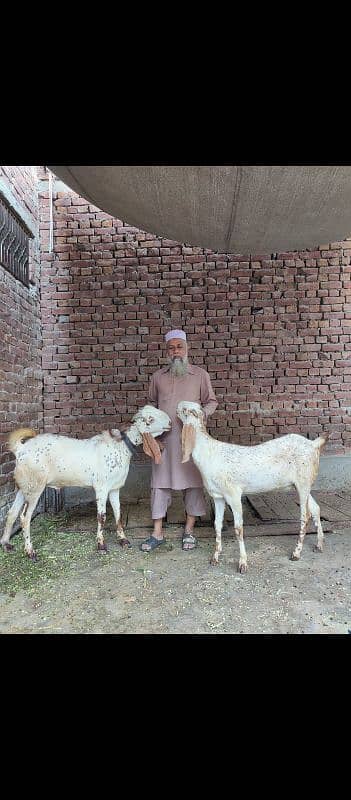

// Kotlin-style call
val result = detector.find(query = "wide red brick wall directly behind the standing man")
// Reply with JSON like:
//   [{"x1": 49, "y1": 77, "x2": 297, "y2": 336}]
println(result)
[{"x1": 40, "y1": 175, "x2": 351, "y2": 453}]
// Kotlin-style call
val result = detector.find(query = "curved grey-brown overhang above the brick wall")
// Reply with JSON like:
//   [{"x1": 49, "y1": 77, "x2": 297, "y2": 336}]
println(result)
[{"x1": 49, "y1": 165, "x2": 351, "y2": 254}]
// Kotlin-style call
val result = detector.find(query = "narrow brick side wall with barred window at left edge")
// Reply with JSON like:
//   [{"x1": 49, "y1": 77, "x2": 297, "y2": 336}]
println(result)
[{"x1": 0, "y1": 166, "x2": 43, "y2": 521}]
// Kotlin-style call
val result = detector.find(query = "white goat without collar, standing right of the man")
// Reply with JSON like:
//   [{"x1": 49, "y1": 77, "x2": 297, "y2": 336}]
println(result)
[{"x1": 177, "y1": 401, "x2": 328, "y2": 572}]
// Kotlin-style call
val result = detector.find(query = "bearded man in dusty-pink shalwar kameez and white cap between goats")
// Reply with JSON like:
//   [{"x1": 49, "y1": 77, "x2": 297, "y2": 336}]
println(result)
[{"x1": 140, "y1": 330, "x2": 218, "y2": 552}]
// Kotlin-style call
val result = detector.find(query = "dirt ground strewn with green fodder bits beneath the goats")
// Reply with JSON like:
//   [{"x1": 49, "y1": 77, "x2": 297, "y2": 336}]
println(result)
[{"x1": 0, "y1": 507, "x2": 351, "y2": 634}]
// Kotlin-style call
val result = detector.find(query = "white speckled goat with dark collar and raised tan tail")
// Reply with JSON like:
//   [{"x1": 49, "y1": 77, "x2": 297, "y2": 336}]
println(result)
[{"x1": 0, "y1": 405, "x2": 171, "y2": 560}]
